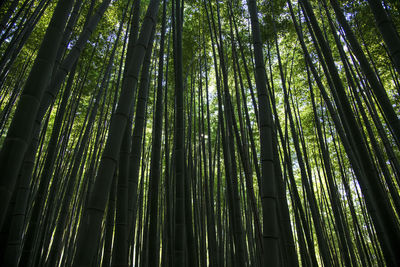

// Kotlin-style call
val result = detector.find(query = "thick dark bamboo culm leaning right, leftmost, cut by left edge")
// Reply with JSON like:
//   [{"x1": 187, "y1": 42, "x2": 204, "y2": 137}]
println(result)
[{"x1": 0, "y1": 0, "x2": 74, "y2": 230}]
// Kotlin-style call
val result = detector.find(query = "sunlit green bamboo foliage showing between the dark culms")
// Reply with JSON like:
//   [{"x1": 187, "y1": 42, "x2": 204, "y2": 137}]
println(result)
[{"x1": 0, "y1": 0, "x2": 400, "y2": 265}]
